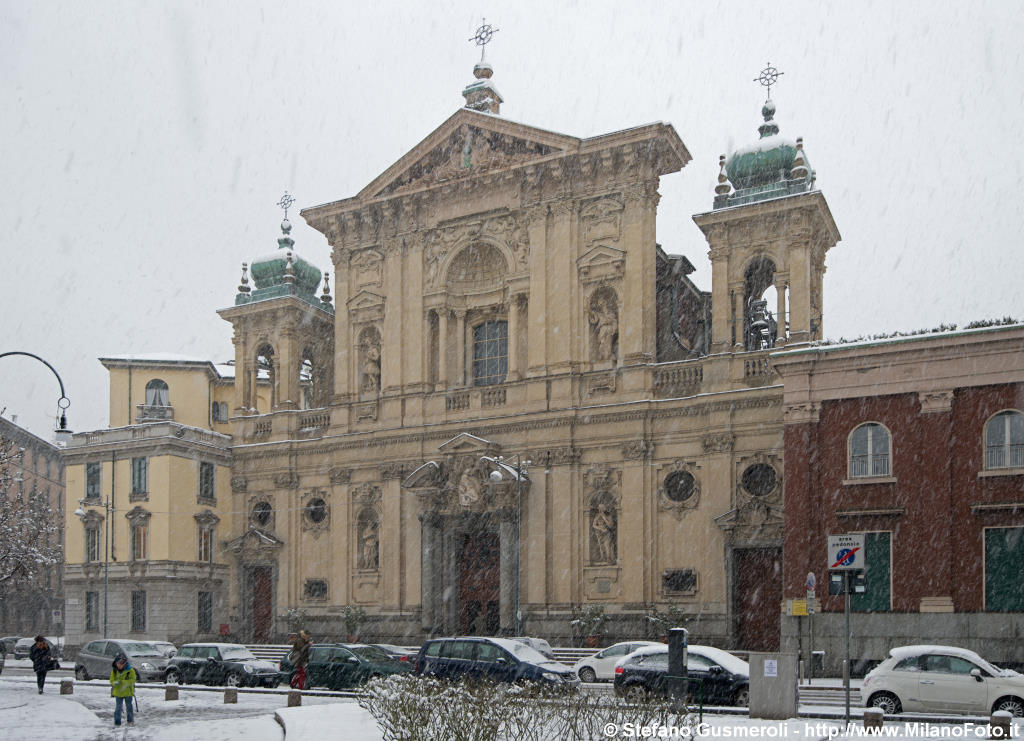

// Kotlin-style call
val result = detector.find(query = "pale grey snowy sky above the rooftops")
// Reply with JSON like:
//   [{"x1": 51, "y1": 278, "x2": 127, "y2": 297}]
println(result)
[{"x1": 0, "y1": 0, "x2": 1024, "y2": 438}]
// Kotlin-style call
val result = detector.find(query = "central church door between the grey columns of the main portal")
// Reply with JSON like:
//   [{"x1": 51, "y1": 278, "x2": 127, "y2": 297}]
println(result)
[{"x1": 459, "y1": 532, "x2": 501, "y2": 636}]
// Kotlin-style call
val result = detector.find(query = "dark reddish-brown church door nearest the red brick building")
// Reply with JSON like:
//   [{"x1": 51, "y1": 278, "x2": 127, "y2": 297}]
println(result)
[{"x1": 732, "y1": 548, "x2": 782, "y2": 651}]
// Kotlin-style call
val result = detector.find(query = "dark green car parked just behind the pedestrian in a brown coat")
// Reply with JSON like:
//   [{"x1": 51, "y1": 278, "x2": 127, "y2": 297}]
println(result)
[{"x1": 281, "y1": 643, "x2": 413, "y2": 690}]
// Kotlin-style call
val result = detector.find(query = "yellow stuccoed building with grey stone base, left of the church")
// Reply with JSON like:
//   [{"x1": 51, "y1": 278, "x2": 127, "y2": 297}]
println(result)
[{"x1": 63, "y1": 354, "x2": 268, "y2": 646}]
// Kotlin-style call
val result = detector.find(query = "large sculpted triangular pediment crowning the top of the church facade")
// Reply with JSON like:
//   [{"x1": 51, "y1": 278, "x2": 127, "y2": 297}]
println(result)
[{"x1": 359, "y1": 108, "x2": 581, "y2": 199}]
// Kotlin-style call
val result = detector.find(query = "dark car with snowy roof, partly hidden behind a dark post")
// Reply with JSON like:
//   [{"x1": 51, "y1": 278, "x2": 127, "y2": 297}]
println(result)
[{"x1": 614, "y1": 644, "x2": 751, "y2": 705}]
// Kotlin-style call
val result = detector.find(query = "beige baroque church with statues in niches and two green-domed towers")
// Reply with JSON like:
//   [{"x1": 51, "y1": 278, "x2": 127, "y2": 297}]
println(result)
[{"x1": 219, "y1": 61, "x2": 840, "y2": 649}]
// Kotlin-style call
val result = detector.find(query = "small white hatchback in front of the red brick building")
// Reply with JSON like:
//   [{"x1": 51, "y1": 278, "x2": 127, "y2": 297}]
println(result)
[{"x1": 860, "y1": 646, "x2": 1024, "y2": 717}]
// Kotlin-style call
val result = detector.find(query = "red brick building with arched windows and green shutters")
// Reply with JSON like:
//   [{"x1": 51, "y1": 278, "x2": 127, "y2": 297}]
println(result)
[{"x1": 773, "y1": 324, "x2": 1024, "y2": 671}]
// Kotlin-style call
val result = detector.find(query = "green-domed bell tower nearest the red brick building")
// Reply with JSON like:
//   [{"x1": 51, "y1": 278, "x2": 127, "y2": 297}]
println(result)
[{"x1": 693, "y1": 73, "x2": 841, "y2": 353}]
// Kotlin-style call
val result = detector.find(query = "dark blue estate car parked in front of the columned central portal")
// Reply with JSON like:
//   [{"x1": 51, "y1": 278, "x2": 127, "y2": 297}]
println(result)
[{"x1": 416, "y1": 638, "x2": 580, "y2": 689}]
